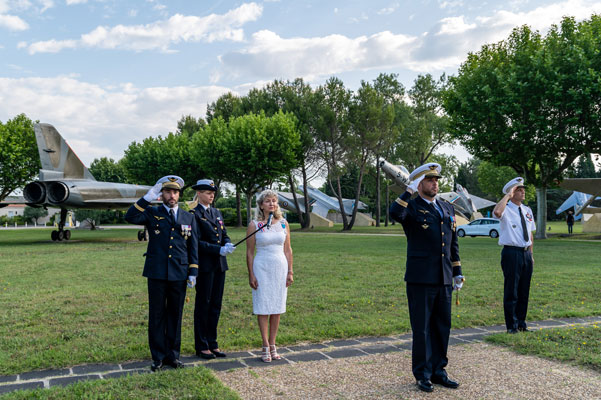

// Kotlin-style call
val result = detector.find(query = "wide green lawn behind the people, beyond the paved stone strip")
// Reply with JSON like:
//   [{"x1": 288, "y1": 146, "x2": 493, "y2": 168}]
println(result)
[{"x1": 0, "y1": 225, "x2": 601, "y2": 375}]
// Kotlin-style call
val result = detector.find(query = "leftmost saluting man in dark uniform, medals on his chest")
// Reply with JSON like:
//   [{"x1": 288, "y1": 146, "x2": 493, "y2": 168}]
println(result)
[{"x1": 125, "y1": 175, "x2": 198, "y2": 371}]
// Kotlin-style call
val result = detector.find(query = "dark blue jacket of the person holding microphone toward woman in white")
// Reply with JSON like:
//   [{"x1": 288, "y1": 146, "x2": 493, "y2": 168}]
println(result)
[{"x1": 190, "y1": 204, "x2": 231, "y2": 272}]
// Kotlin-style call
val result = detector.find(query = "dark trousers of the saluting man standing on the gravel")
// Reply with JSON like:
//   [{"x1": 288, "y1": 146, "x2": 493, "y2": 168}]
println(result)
[{"x1": 407, "y1": 283, "x2": 453, "y2": 380}]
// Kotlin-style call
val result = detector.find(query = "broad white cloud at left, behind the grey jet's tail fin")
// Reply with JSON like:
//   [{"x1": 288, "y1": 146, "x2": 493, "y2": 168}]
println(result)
[{"x1": 0, "y1": 77, "x2": 229, "y2": 165}]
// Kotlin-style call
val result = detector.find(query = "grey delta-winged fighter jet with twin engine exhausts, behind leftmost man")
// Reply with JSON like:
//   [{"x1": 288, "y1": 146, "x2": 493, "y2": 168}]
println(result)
[{"x1": 0, "y1": 124, "x2": 150, "y2": 241}]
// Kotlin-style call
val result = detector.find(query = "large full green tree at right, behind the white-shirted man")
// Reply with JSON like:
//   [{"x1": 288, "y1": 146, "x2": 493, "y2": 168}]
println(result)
[{"x1": 444, "y1": 16, "x2": 601, "y2": 238}]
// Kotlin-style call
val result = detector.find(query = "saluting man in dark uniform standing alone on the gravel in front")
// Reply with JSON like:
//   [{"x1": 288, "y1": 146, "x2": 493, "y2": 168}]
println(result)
[{"x1": 390, "y1": 163, "x2": 464, "y2": 392}]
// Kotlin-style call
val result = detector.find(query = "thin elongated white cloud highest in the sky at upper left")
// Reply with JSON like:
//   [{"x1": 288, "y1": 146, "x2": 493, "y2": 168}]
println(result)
[{"x1": 28, "y1": 3, "x2": 263, "y2": 54}]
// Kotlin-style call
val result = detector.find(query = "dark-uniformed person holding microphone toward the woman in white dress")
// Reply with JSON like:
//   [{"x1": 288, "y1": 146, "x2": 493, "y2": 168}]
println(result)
[{"x1": 190, "y1": 179, "x2": 234, "y2": 359}]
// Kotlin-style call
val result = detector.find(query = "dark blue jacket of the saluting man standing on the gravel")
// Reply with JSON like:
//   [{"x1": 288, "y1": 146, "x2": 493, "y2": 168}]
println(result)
[{"x1": 390, "y1": 192, "x2": 462, "y2": 285}]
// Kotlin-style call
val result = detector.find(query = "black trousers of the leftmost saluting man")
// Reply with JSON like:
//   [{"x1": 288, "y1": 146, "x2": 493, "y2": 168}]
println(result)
[{"x1": 148, "y1": 279, "x2": 186, "y2": 361}]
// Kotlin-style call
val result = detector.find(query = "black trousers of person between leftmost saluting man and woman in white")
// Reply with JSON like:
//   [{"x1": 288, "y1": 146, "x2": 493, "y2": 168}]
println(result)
[{"x1": 194, "y1": 271, "x2": 225, "y2": 353}]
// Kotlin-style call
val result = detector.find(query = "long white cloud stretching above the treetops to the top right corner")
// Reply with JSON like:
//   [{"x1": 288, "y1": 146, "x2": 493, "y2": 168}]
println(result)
[{"x1": 214, "y1": 0, "x2": 601, "y2": 82}]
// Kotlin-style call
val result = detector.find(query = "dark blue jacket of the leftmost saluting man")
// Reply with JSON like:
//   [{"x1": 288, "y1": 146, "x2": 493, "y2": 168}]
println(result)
[{"x1": 125, "y1": 198, "x2": 198, "y2": 281}]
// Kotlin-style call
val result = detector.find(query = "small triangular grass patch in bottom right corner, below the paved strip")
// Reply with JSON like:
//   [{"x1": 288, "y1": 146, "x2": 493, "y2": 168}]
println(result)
[{"x1": 486, "y1": 324, "x2": 601, "y2": 372}]
